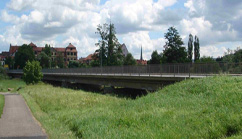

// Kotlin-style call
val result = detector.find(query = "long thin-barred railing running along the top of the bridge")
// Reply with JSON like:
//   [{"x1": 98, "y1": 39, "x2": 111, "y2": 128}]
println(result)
[{"x1": 9, "y1": 62, "x2": 242, "y2": 77}]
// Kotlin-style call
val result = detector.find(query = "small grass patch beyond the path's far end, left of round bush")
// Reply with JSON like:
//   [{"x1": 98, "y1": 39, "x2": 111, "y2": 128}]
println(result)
[{"x1": 0, "y1": 79, "x2": 26, "y2": 92}]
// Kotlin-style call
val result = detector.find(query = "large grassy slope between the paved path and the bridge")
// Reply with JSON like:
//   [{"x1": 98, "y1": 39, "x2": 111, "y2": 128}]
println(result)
[{"x1": 0, "y1": 76, "x2": 242, "y2": 139}]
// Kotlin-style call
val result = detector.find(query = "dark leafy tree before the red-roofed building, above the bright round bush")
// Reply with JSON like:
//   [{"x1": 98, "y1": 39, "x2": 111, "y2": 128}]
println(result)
[{"x1": 14, "y1": 44, "x2": 35, "y2": 69}]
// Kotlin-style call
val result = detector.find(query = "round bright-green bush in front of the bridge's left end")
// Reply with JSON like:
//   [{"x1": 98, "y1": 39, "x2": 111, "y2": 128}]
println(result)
[{"x1": 23, "y1": 61, "x2": 43, "y2": 84}]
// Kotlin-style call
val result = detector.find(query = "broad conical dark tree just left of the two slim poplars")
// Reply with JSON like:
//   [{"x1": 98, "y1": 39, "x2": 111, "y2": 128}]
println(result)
[{"x1": 163, "y1": 27, "x2": 188, "y2": 63}]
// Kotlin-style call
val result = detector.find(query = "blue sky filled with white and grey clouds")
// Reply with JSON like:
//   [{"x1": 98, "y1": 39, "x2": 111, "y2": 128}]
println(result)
[{"x1": 0, "y1": 0, "x2": 242, "y2": 60}]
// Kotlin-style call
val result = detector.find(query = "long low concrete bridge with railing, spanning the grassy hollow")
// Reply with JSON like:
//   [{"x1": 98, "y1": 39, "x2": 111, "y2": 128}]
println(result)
[{"x1": 8, "y1": 64, "x2": 242, "y2": 90}]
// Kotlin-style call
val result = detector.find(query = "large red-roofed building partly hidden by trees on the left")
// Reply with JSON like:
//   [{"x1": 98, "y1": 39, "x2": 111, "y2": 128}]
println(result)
[{"x1": 1, "y1": 42, "x2": 77, "y2": 65}]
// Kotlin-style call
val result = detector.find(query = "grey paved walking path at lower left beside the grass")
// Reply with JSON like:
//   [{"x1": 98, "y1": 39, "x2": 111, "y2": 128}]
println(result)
[{"x1": 0, "y1": 93, "x2": 47, "y2": 139}]
